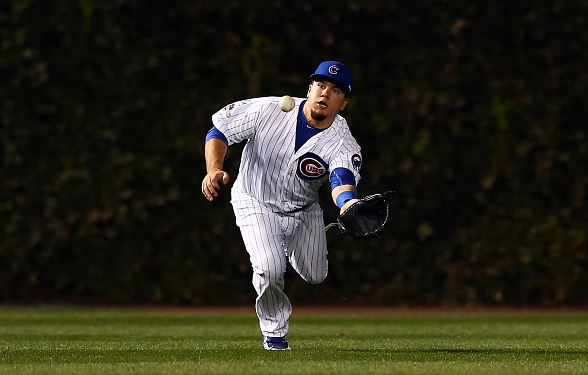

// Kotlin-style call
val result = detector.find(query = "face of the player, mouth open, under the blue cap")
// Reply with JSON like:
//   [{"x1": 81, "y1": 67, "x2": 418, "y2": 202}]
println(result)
[{"x1": 306, "y1": 81, "x2": 349, "y2": 121}]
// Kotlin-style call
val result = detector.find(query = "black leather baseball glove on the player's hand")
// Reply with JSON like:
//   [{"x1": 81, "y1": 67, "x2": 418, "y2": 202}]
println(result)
[{"x1": 325, "y1": 191, "x2": 397, "y2": 239}]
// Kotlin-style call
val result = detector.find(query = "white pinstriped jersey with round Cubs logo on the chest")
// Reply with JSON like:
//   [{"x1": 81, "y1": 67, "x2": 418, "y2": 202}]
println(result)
[{"x1": 212, "y1": 97, "x2": 361, "y2": 213}]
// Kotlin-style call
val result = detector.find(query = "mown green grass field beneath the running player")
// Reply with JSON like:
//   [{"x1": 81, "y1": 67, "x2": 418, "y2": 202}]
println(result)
[{"x1": 0, "y1": 307, "x2": 588, "y2": 375}]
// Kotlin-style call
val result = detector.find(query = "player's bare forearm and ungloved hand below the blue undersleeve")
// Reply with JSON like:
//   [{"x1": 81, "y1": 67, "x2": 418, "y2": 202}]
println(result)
[{"x1": 202, "y1": 138, "x2": 230, "y2": 201}]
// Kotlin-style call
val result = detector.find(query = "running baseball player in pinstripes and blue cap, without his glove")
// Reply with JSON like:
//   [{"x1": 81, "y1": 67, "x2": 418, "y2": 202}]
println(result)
[{"x1": 202, "y1": 61, "x2": 362, "y2": 350}]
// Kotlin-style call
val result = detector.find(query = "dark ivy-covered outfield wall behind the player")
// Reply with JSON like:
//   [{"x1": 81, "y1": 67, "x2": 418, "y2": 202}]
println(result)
[{"x1": 0, "y1": 0, "x2": 588, "y2": 306}]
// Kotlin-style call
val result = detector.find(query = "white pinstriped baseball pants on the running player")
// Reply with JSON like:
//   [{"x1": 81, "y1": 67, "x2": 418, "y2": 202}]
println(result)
[{"x1": 231, "y1": 194, "x2": 328, "y2": 337}]
